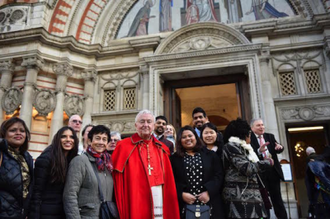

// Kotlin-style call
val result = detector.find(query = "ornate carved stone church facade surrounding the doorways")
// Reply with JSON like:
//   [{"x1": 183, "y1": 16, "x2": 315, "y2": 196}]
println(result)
[{"x1": 0, "y1": 0, "x2": 330, "y2": 218}]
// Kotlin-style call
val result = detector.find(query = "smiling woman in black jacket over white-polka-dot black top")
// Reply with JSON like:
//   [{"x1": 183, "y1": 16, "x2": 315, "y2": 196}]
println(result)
[{"x1": 170, "y1": 126, "x2": 224, "y2": 219}]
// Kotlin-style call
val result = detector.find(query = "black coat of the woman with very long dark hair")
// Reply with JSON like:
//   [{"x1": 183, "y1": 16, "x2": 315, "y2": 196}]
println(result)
[{"x1": 29, "y1": 146, "x2": 65, "y2": 219}]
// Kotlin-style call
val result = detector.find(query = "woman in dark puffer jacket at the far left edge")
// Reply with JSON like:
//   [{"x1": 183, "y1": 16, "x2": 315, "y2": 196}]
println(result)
[{"x1": 0, "y1": 117, "x2": 33, "y2": 219}]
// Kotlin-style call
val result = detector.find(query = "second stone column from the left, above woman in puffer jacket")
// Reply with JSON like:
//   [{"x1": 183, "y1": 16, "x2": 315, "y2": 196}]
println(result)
[{"x1": 20, "y1": 56, "x2": 43, "y2": 129}]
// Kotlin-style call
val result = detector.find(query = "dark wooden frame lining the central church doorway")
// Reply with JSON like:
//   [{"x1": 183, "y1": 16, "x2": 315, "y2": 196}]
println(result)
[{"x1": 164, "y1": 73, "x2": 252, "y2": 124}]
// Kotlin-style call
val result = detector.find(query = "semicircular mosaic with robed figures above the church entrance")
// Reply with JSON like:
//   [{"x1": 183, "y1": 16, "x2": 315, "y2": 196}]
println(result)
[{"x1": 117, "y1": 0, "x2": 295, "y2": 38}]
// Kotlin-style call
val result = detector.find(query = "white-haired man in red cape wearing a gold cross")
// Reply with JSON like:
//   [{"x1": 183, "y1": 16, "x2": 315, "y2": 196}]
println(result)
[{"x1": 112, "y1": 110, "x2": 180, "y2": 219}]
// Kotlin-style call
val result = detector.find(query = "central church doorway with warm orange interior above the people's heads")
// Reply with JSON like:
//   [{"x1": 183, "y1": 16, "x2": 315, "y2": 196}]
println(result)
[{"x1": 164, "y1": 74, "x2": 251, "y2": 130}]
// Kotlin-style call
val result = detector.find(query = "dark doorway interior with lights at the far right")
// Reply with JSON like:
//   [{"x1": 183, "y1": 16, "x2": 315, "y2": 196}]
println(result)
[{"x1": 286, "y1": 121, "x2": 330, "y2": 218}]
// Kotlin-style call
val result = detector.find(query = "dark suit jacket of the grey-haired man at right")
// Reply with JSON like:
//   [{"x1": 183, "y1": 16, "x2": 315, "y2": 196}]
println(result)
[{"x1": 251, "y1": 133, "x2": 284, "y2": 181}]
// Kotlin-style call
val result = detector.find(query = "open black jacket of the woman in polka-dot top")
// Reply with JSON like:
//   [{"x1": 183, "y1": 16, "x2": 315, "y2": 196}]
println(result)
[{"x1": 170, "y1": 148, "x2": 224, "y2": 219}]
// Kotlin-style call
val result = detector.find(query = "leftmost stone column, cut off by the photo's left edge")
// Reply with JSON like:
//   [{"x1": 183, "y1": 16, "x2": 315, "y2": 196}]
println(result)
[{"x1": 0, "y1": 59, "x2": 15, "y2": 123}]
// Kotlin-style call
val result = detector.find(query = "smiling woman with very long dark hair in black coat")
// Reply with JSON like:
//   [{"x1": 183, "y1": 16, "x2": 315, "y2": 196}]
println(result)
[{"x1": 29, "y1": 126, "x2": 79, "y2": 219}]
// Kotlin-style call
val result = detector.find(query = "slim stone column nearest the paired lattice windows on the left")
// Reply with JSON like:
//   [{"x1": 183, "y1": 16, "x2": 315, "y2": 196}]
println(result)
[{"x1": 82, "y1": 70, "x2": 97, "y2": 127}]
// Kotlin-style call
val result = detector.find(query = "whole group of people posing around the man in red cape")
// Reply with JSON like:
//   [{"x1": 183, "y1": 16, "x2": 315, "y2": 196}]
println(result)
[{"x1": 0, "y1": 107, "x2": 328, "y2": 219}]
